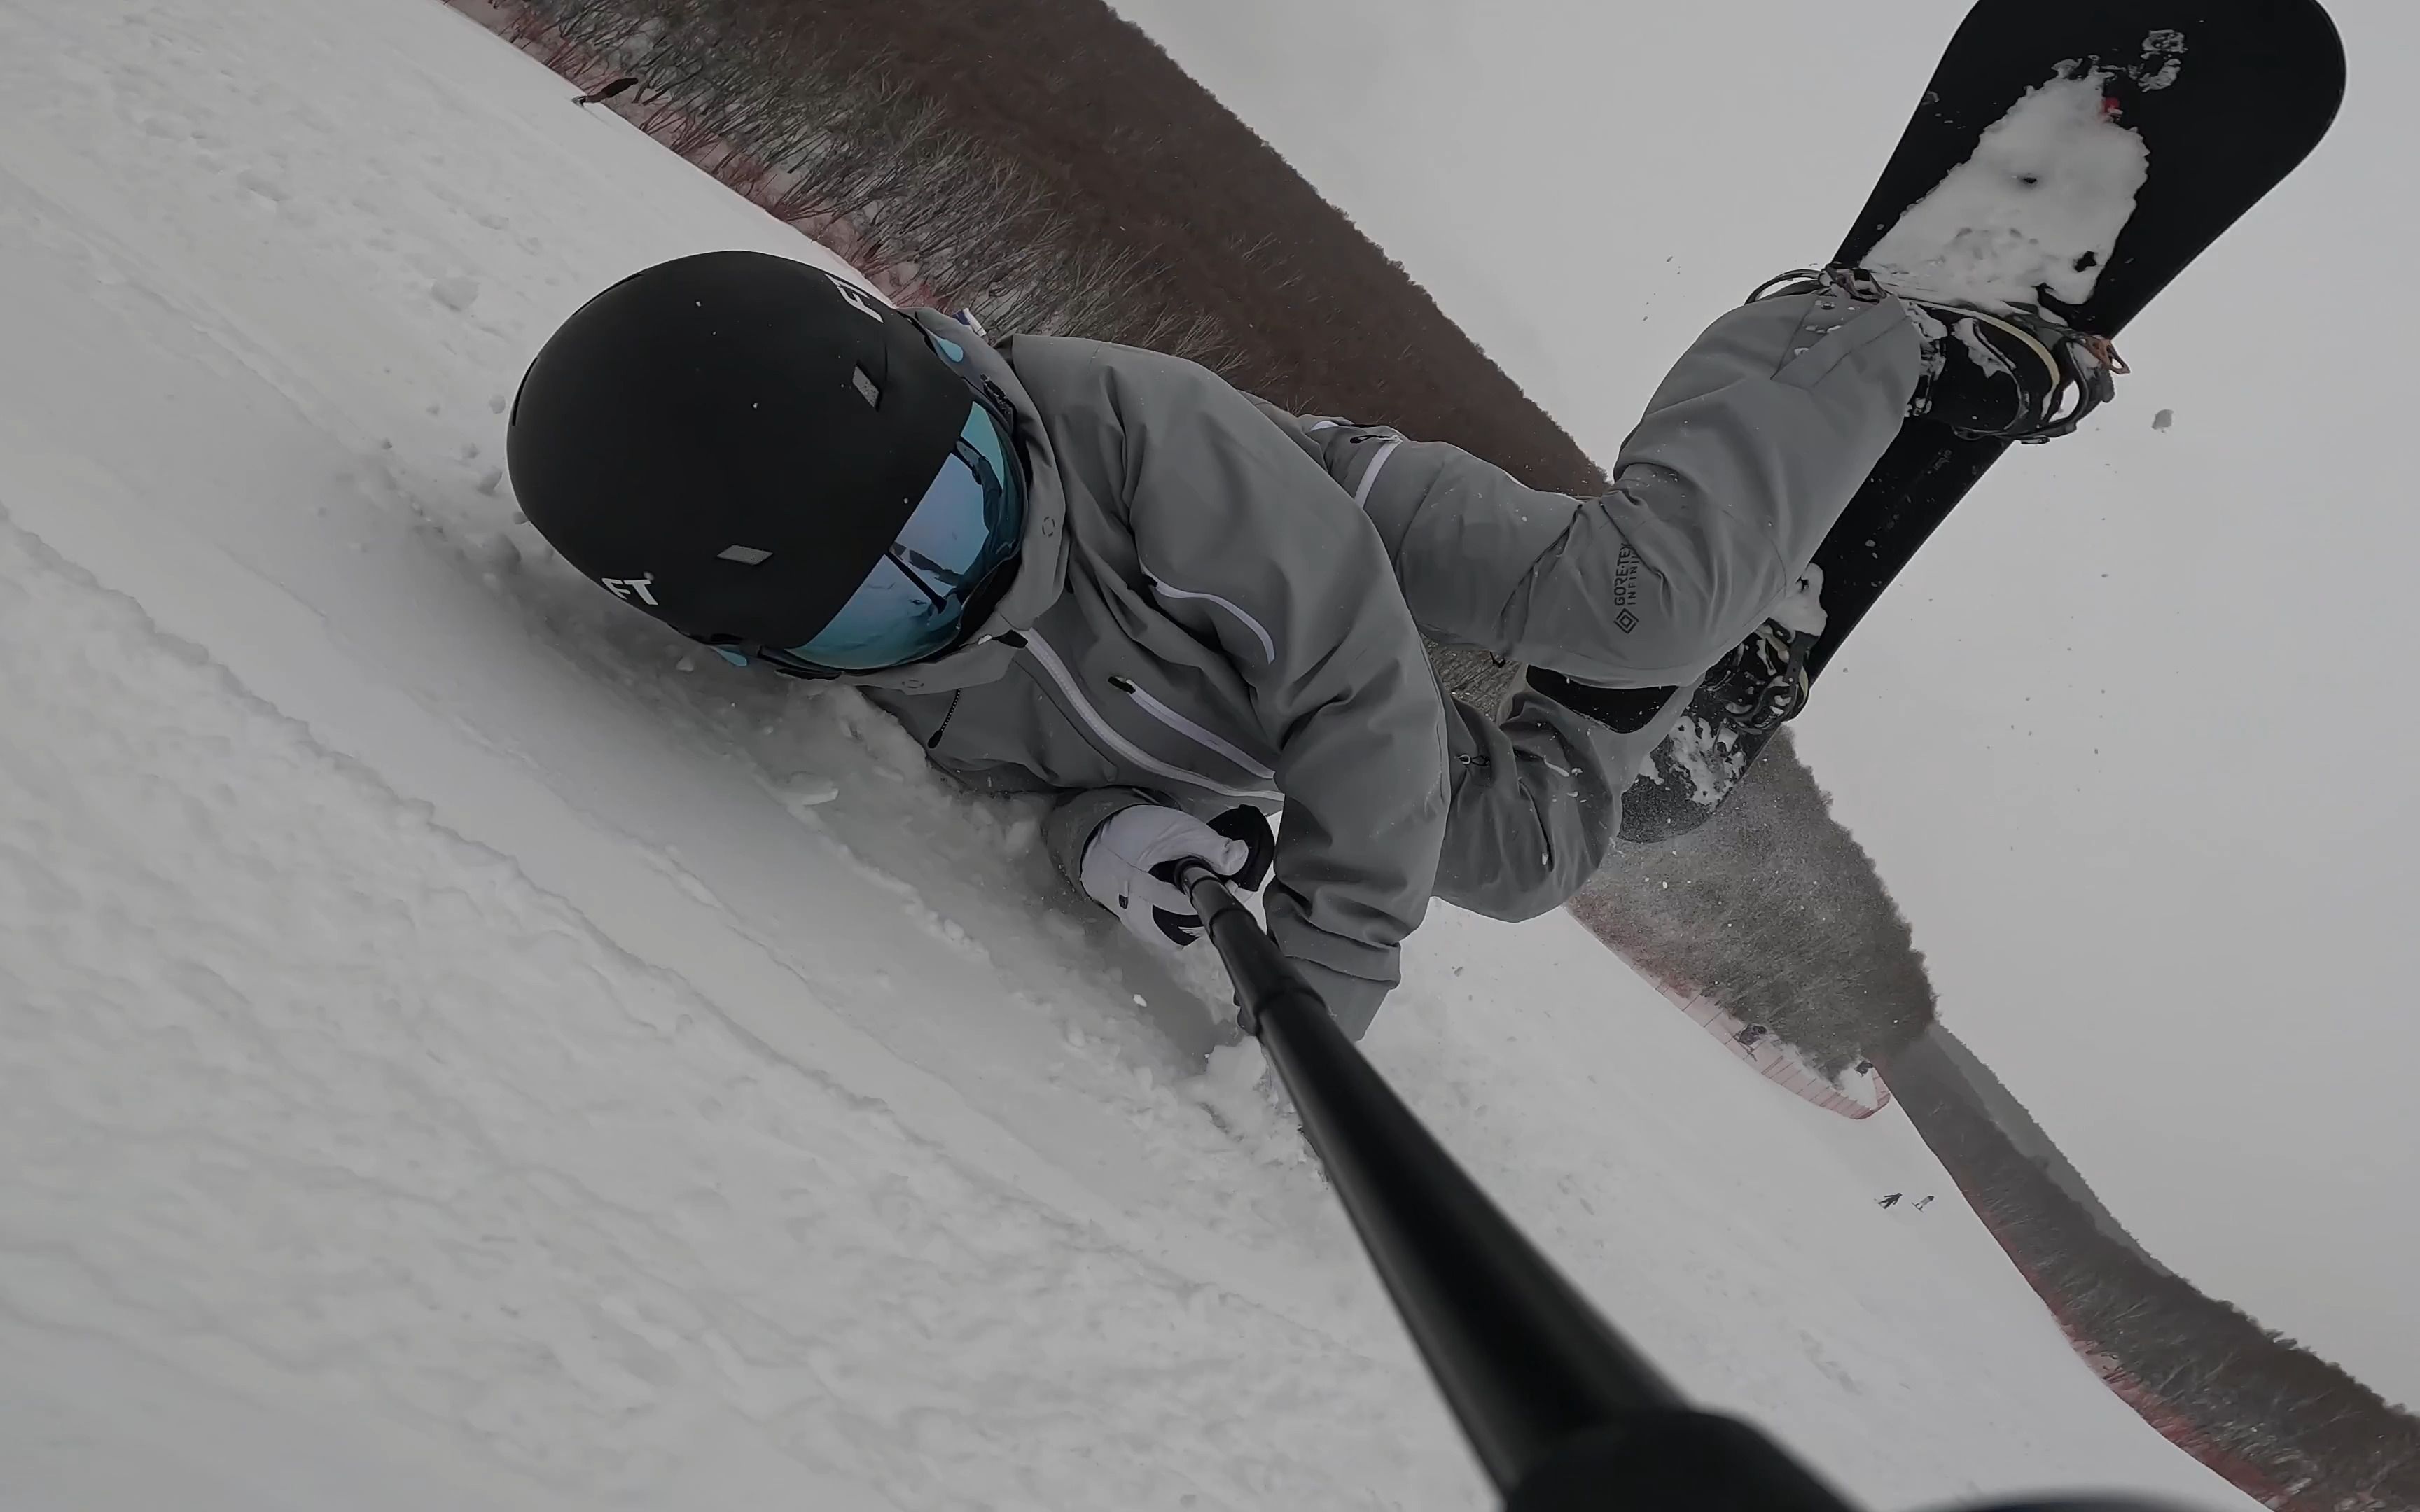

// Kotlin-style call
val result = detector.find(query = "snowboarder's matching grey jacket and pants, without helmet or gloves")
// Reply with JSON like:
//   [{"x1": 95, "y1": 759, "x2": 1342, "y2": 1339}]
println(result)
[{"x1": 847, "y1": 295, "x2": 1919, "y2": 1035}]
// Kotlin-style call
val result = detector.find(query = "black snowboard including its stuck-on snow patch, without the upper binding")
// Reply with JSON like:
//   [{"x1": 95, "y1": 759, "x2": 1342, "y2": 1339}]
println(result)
[{"x1": 1622, "y1": 0, "x2": 2345, "y2": 842}]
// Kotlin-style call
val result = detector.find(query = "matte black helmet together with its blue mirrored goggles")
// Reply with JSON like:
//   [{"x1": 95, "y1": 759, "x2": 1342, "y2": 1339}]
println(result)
[{"x1": 506, "y1": 251, "x2": 1024, "y2": 670}]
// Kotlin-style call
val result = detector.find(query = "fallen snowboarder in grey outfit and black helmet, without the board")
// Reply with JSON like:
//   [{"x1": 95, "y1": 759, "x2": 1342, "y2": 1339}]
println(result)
[{"x1": 508, "y1": 251, "x2": 2100, "y2": 1035}]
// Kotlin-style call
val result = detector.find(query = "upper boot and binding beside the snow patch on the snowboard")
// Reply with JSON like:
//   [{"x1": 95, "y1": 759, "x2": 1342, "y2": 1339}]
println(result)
[{"x1": 1747, "y1": 269, "x2": 2127, "y2": 442}]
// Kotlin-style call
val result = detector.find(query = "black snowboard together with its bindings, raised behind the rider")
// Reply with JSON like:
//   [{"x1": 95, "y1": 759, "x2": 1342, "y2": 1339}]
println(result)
[{"x1": 1622, "y1": 0, "x2": 2345, "y2": 844}]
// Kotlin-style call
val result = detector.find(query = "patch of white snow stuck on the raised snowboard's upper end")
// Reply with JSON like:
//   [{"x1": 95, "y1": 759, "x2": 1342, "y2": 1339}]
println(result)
[{"x1": 1866, "y1": 69, "x2": 2173, "y2": 309}]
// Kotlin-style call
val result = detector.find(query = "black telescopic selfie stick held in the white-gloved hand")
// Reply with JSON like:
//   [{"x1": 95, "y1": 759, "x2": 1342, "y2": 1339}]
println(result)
[{"x1": 1178, "y1": 864, "x2": 1847, "y2": 1512}]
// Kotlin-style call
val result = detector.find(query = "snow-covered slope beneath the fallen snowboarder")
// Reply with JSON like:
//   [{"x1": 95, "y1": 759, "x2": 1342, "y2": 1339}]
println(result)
[{"x1": 0, "y1": 0, "x2": 2241, "y2": 1512}]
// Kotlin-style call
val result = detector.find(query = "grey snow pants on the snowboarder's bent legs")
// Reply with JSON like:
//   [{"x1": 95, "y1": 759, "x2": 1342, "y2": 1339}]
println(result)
[{"x1": 1302, "y1": 290, "x2": 1921, "y2": 919}]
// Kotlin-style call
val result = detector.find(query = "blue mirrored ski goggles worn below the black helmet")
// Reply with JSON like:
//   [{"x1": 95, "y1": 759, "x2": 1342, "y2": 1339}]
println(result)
[{"x1": 714, "y1": 402, "x2": 1026, "y2": 678}]
